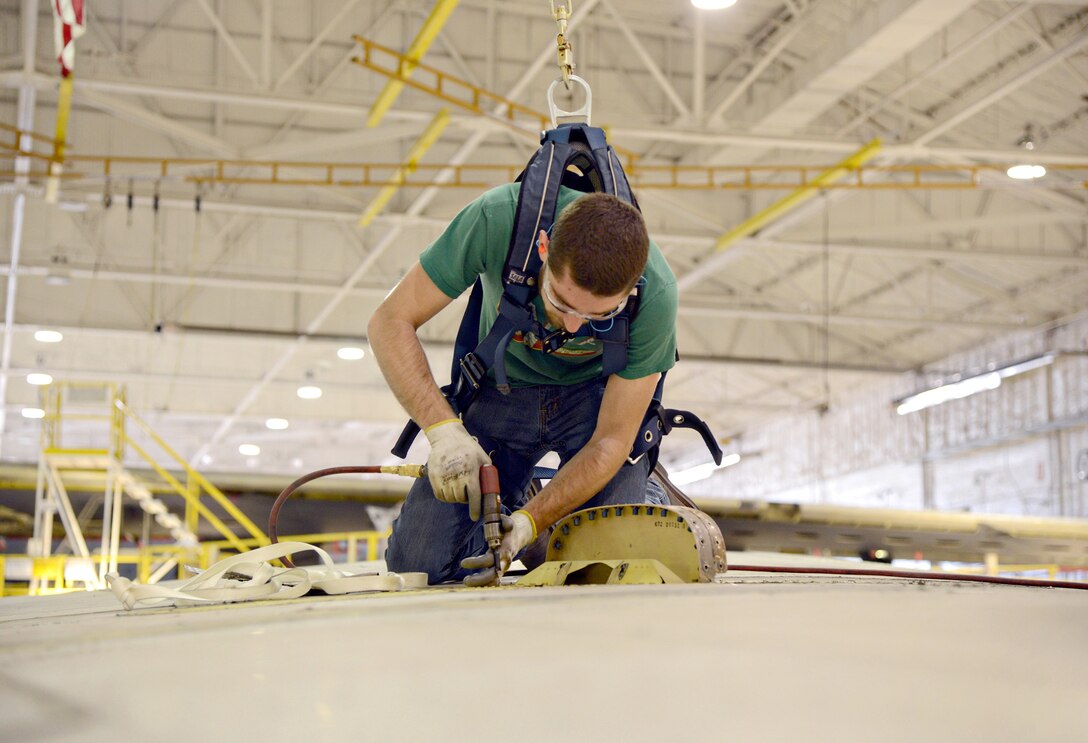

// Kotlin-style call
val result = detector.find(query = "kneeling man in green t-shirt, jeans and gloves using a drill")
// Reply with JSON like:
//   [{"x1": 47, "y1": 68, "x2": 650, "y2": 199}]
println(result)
[{"x1": 368, "y1": 184, "x2": 677, "y2": 584}]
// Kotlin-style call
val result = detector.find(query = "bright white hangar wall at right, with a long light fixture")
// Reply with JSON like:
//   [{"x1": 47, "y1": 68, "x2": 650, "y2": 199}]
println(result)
[{"x1": 688, "y1": 314, "x2": 1088, "y2": 517}]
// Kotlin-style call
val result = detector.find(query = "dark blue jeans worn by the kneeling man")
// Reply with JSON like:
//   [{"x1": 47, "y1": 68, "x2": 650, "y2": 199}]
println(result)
[{"x1": 385, "y1": 380, "x2": 668, "y2": 584}]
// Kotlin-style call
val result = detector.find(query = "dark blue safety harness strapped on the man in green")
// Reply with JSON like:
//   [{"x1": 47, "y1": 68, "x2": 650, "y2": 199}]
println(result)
[{"x1": 393, "y1": 123, "x2": 721, "y2": 466}]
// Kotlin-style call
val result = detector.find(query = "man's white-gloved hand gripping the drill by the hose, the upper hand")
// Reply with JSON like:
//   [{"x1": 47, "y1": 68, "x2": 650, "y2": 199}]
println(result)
[{"x1": 423, "y1": 418, "x2": 491, "y2": 521}]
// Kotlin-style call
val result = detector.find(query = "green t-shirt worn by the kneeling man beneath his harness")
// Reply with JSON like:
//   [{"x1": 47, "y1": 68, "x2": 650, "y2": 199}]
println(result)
[{"x1": 420, "y1": 184, "x2": 677, "y2": 387}]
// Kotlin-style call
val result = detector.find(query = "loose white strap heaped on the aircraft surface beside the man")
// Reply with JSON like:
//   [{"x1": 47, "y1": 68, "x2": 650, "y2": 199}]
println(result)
[{"x1": 106, "y1": 542, "x2": 426, "y2": 609}]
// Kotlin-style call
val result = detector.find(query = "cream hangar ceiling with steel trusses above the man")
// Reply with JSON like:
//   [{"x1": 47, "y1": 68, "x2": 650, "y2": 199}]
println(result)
[{"x1": 0, "y1": 0, "x2": 1088, "y2": 472}]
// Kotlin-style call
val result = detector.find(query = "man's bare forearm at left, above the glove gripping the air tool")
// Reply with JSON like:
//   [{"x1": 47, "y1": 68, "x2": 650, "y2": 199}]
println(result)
[{"x1": 368, "y1": 314, "x2": 454, "y2": 429}]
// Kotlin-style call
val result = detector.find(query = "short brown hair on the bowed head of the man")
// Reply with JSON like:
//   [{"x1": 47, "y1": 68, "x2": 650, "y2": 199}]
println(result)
[{"x1": 547, "y1": 194, "x2": 650, "y2": 297}]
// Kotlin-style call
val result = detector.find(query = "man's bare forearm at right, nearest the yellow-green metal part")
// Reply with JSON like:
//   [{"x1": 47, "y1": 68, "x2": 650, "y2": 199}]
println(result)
[{"x1": 524, "y1": 438, "x2": 630, "y2": 532}]
